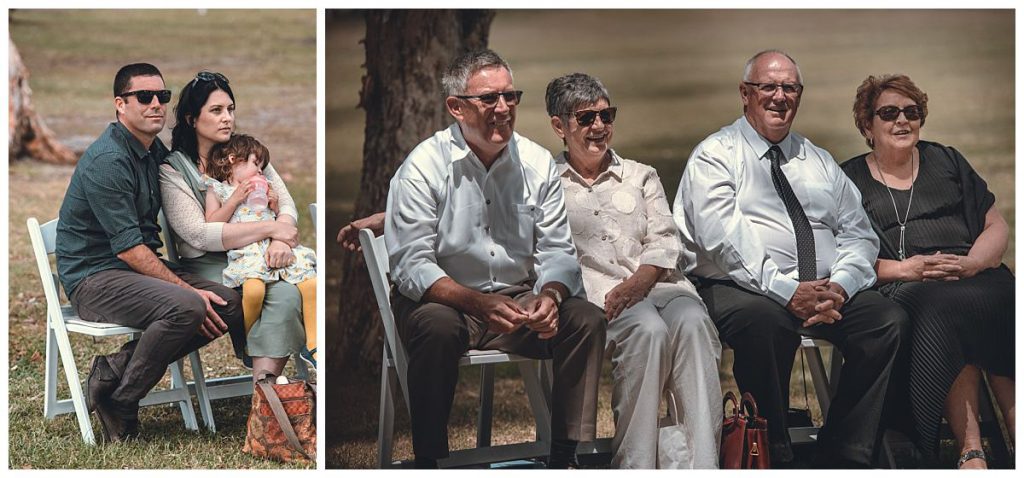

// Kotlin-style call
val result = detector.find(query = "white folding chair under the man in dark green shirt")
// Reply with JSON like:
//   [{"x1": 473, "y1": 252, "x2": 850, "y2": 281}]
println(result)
[{"x1": 28, "y1": 217, "x2": 199, "y2": 444}]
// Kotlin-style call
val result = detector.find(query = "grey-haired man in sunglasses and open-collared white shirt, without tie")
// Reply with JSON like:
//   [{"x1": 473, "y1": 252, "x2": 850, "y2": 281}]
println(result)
[{"x1": 384, "y1": 50, "x2": 605, "y2": 468}]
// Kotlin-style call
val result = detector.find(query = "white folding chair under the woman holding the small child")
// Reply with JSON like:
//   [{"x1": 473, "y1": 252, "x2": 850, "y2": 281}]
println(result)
[{"x1": 158, "y1": 211, "x2": 309, "y2": 433}]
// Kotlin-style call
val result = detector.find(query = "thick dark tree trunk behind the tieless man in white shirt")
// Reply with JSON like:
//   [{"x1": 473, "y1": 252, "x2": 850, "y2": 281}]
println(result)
[{"x1": 326, "y1": 10, "x2": 495, "y2": 382}]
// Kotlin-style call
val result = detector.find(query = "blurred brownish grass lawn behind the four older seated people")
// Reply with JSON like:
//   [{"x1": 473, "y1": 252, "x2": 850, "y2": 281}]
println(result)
[{"x1": 325, "y1": 10, "x2": 1015, "y2": 468}]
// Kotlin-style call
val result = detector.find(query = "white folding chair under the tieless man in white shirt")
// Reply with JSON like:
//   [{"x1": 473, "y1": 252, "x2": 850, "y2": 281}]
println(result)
[{"x1": 359, "y1": 229, "x2": 551, "y2": 468}]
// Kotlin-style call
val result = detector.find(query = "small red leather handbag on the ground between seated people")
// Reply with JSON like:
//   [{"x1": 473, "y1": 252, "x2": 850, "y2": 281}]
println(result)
[{"x1": 718, "y1": 391, "x2": 771, "y2": 470}]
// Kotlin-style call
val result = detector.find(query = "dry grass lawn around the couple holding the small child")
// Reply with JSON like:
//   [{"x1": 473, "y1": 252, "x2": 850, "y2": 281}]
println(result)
[{"x1": 8, "y1": 10, "x2": 316, "y2": 469}]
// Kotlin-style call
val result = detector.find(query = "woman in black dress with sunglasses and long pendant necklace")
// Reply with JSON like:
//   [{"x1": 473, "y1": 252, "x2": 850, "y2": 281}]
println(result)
[{"x1": 843, "y1": 75, "x2": 1016, "y2": 468}]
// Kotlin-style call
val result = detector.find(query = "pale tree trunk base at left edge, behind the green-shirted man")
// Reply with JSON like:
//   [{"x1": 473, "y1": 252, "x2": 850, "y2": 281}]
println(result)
[{"x1": 7, "y1": 39, "x2": 78, "y2": 164}]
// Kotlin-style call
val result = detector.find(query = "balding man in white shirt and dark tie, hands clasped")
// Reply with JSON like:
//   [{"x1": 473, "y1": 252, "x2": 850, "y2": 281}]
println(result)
[{"x1": 674, "y1": 50, "x2": 910, "y2": 467}]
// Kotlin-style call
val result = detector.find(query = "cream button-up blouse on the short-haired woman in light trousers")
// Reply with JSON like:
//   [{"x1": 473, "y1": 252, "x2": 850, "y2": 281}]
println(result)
[{"x1": 555, "y1": 150, "x2": 699, "y2": 308}]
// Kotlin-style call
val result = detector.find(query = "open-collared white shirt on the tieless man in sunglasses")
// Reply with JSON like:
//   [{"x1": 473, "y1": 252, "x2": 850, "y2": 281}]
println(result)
[{"x1": 384, "y1": 124, "x2": 583, "y2": 301}]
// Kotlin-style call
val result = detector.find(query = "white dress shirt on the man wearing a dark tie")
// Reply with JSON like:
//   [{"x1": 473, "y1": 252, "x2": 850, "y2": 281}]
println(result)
[{"x1": 673, "y1": 117, "x2": 879, "y2": 305}]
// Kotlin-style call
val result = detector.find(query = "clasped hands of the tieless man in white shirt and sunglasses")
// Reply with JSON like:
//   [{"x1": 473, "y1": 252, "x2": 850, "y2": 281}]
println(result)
[{"x1": 473, "y1": 294, "x2": 558, "y2": 339}]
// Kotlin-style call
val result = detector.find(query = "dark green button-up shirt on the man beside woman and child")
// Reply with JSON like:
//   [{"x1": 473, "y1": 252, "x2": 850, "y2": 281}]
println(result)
[{"x1": 56, "y1": 122, "x2": 167, "y2": 296}]
